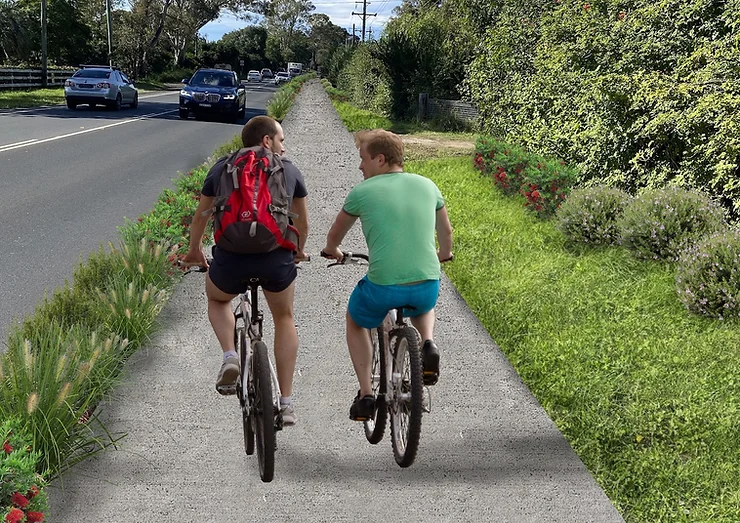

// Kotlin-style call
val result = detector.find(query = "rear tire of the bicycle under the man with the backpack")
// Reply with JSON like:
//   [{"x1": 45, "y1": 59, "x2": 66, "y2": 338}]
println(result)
[{"x1": 252, "y1": 341, "x2": 275, "y2": 483}]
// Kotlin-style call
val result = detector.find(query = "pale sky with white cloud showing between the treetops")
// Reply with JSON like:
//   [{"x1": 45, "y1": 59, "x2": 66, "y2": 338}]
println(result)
[{"x1": 200, "y1": 0, "x2": 401, "y2": 42}]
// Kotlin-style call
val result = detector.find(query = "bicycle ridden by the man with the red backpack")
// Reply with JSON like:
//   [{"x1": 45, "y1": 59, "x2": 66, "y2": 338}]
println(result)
[{"x1": 185, "y1": 266, "x2": 283, "y2": 483}]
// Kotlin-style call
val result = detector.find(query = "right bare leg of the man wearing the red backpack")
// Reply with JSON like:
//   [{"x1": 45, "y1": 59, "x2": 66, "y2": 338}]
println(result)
[{"x1": 262, "y1": 282, "x2": 298, "y2": 397}]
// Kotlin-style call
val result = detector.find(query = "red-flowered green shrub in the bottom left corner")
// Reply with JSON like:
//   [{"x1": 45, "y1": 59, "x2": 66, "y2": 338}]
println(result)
[{"x1": 0, "y1": 418, "x2": 47, "y2": 523}]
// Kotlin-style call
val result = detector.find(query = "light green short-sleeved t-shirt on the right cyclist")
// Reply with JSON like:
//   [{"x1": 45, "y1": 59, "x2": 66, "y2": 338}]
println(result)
[{"x1": 343, "y1": 173, "x2": 445, "y2": 285}]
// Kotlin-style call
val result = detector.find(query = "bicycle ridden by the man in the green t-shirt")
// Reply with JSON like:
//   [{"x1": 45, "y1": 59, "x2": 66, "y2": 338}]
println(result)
[{"x1": 321, "y1": 252, "x2": 431, "y2": 468}]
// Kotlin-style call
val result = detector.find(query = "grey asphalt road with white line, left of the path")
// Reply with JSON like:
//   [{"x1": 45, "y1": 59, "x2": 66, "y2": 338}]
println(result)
[{"x1": 0, "y1": 84, "x2": 275, "y2": 344}]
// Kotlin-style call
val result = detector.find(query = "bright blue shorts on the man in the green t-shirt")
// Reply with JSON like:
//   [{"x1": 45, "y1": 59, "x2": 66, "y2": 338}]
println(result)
[{"x1": 347, "y1": 276, "x2": 439, "y2": 329}]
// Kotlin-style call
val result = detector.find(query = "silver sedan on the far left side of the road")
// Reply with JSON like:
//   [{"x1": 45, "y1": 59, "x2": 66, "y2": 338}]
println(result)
[{"x1": 64, "y1": 65, "x2": 139, "y2": 110}]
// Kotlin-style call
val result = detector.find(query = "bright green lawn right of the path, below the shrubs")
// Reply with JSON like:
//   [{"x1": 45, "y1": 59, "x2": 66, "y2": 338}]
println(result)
[{"x1": 416, "y1": 158, "x2": 740, "y2": 523}]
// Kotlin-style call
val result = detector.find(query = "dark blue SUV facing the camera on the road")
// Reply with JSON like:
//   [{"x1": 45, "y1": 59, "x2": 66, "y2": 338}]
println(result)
[{"x1": 180, "y1": 69, "x2": 247, "y2": 121}]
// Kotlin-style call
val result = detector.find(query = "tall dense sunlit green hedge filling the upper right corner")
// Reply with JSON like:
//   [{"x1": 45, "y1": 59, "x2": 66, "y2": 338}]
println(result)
[{"x1": 464, "y1": 0, "x2": 740, "y2": 215}]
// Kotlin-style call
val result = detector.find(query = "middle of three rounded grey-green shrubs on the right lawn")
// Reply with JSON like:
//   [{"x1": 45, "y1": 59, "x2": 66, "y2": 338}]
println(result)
[{"x1": 617, "y1": 187, "x2": 726, "y2": 261}]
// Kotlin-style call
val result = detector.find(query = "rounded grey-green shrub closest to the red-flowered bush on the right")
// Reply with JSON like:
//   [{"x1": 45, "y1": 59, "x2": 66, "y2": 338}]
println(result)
[{"x1": 556, "y1": 186, "x2": 629, "y2": 245}]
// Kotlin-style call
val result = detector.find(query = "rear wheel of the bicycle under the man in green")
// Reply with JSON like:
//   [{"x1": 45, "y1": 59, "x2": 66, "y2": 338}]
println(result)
[{"x1": 390, "y1": 326, "x2": 424, "y2": 467}]
